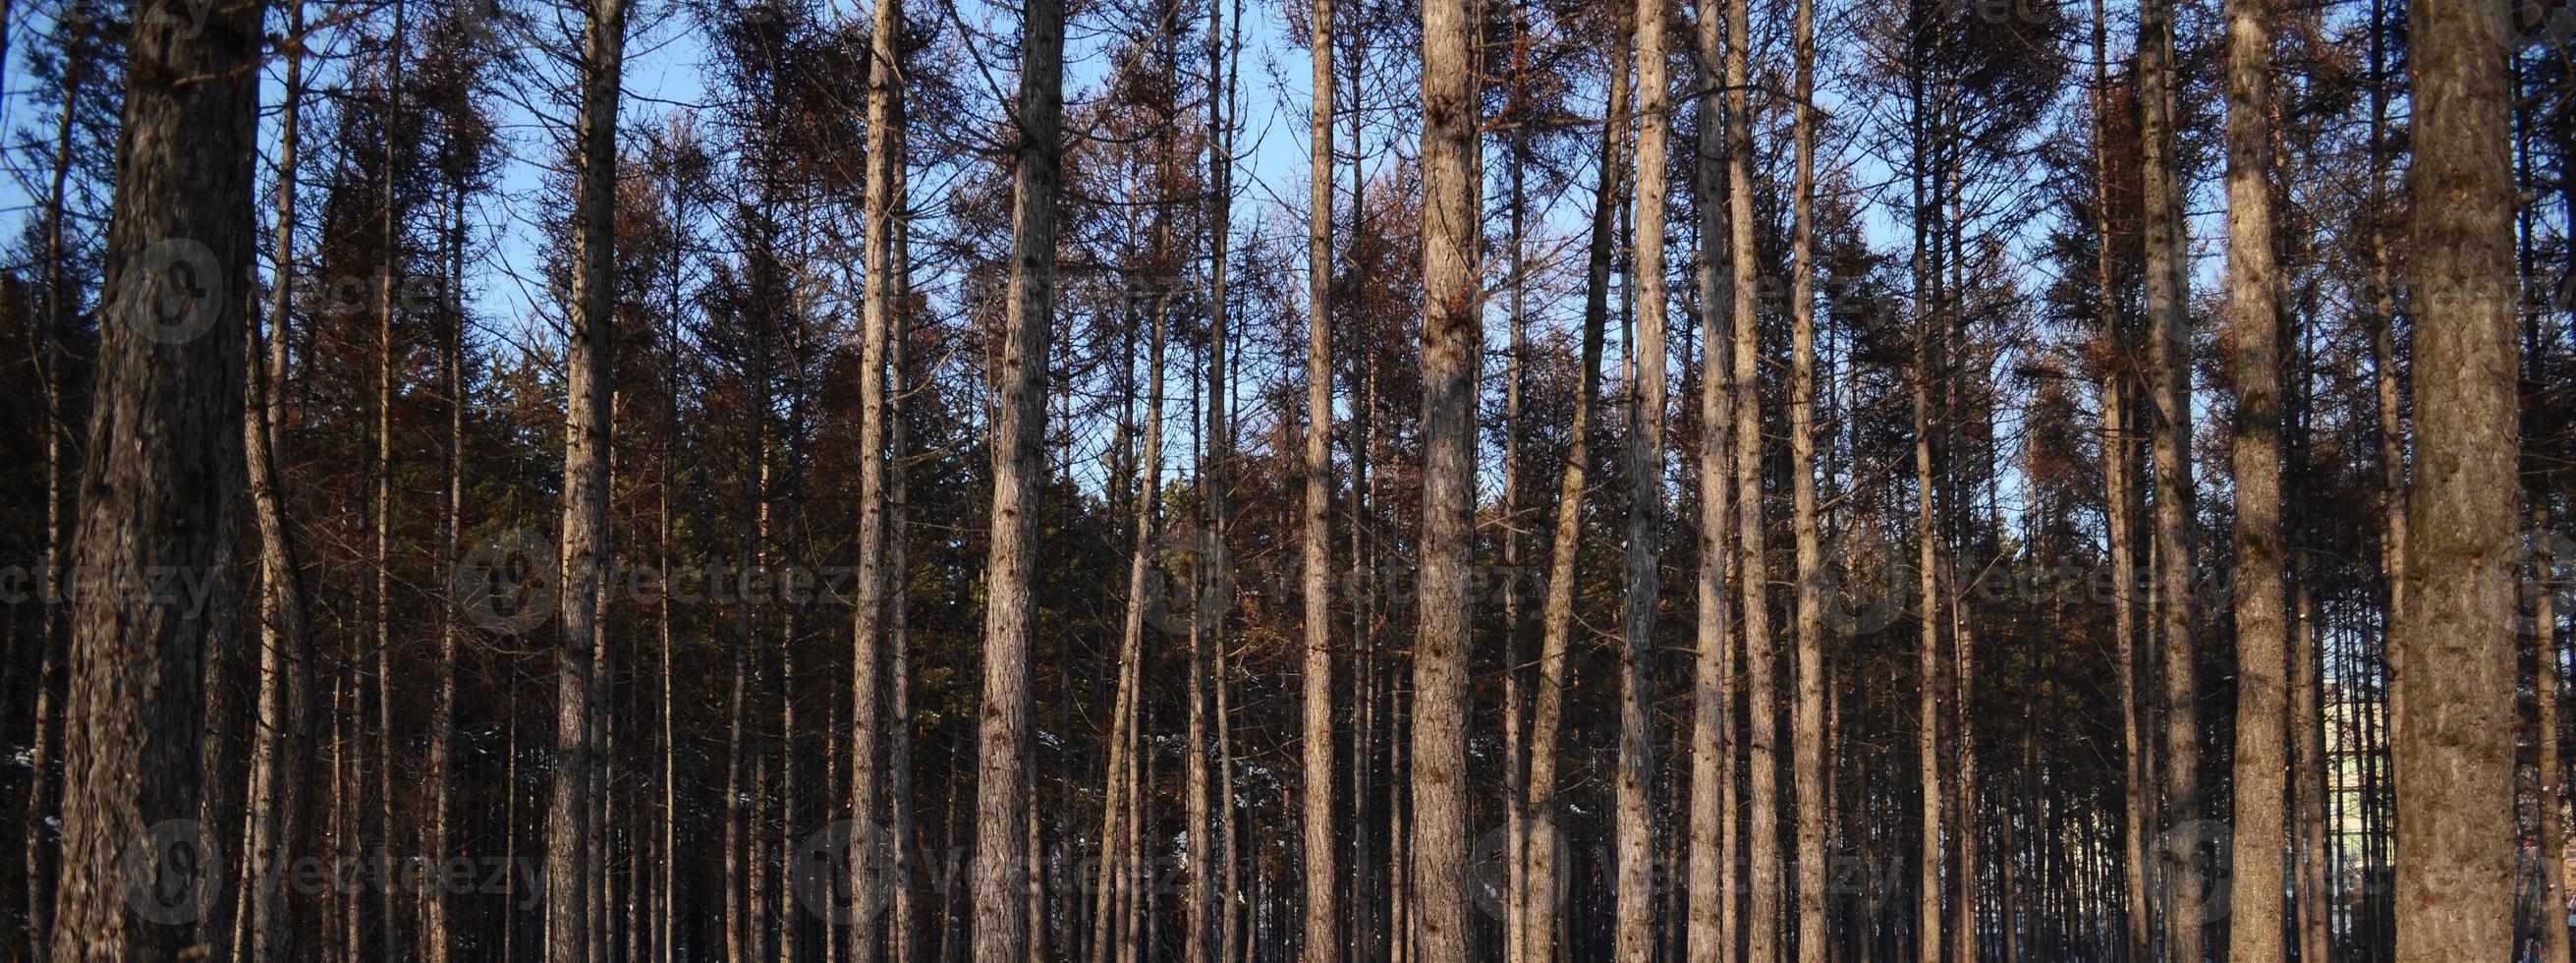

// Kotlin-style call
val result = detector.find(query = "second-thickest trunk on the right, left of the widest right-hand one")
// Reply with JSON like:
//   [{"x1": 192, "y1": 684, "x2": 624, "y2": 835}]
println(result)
[{"x1": 2225, "y1": 0, "x2": 2290, "y2": 963}]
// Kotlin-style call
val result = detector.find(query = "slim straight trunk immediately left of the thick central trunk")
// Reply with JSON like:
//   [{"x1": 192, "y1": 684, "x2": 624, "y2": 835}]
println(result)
[{"x1": 1298, "y1": 0, "x2": 1339, "y2": 947}]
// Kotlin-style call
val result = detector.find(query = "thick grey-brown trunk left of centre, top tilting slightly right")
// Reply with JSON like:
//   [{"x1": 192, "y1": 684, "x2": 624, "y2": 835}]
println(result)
[{"x1": 974, "y1": 0, "x2": 1064, "y2": 963}]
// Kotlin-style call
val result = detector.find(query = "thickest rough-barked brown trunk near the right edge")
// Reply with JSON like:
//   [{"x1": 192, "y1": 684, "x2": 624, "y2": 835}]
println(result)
[{"x1": 2388, "y1": 0, "x2": 2522, "y2": 963}]
